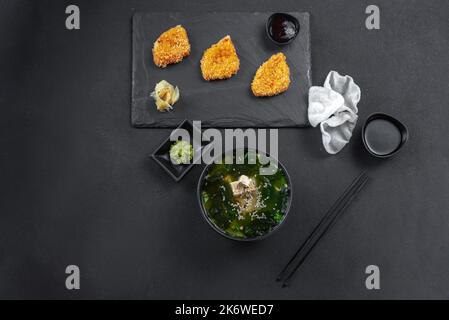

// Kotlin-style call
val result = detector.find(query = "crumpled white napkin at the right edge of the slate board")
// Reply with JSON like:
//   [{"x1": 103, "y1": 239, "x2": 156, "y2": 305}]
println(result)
[{"x1": 309, "y1": 71, "x2": 361, "y2": 154}]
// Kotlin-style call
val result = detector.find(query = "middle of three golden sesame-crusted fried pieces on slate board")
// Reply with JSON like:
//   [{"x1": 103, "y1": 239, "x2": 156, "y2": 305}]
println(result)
[{"x1": 201, "y1": 36, "x2": 240, "y2": 81}]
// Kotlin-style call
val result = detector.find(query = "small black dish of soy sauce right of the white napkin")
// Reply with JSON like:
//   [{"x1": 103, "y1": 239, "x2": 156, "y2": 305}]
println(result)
[{"x1": 362, "y1": 113, "x2": 409, "y2": 158}]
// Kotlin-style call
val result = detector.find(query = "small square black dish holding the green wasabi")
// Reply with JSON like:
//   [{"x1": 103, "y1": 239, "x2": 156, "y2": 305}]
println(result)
[{"x1": 151, "y1": 119, "x2": 207, "y2": 182}]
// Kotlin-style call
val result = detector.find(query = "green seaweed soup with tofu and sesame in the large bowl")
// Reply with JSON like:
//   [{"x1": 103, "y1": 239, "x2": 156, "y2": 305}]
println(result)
[{"x1": 200, "y1": 151, "x2": 290, "y2": 239}]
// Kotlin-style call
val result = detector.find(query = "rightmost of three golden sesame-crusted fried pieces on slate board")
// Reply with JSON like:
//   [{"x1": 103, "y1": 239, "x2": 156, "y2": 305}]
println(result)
[{"x1": 251, "y1": 53, "x2": 290, "y2": 97}]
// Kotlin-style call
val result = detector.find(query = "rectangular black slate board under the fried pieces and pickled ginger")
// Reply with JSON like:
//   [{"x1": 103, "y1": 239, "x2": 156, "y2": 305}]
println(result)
[{"x1": 131, "y1": 12, "x2": 311, "y2": 128}]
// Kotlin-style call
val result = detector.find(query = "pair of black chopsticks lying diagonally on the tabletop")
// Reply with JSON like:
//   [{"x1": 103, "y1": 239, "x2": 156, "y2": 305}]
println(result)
[{"x1": 276, "y1": 172, "x2": 368, "y2": 287}]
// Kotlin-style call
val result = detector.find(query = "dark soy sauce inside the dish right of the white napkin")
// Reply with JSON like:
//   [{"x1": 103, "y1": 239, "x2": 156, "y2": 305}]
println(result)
[{"x1": 365, "y1": 119, "x2": 402, "y2": 156}]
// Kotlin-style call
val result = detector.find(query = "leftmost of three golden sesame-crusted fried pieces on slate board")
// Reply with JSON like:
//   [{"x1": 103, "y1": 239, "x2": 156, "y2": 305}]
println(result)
[{"x1": 153, "y1": 25, "x2": 190, "y2": 68}]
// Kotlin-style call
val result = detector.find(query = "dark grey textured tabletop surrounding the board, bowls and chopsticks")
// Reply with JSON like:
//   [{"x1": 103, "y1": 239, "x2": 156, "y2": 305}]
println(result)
[{"x1": 0, "y1": 0, "x2": 449, "y2": 299}]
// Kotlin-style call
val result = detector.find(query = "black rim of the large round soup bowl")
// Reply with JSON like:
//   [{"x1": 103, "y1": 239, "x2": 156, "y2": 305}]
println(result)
[{"x1": 197, "y1": 150, "x2": 293, "y2": 242}]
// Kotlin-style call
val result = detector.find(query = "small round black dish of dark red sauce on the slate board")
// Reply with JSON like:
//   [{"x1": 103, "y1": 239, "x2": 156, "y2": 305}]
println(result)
[{"x1": 265, "y1": 12, "x2": 301, "y2": 46}]
